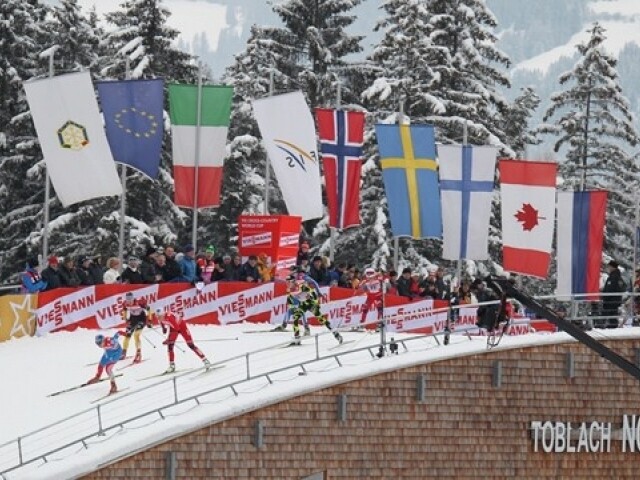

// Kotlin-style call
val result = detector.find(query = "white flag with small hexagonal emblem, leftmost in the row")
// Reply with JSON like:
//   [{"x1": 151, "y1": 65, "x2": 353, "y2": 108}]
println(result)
[{"x1": 24, "y1": 72, "x2": 122, "y2": 207}]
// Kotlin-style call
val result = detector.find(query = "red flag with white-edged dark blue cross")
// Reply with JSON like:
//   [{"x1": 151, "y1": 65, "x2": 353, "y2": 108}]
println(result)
[{"x1": 316, "y1": 108, "x2": 364, "y2": 228}]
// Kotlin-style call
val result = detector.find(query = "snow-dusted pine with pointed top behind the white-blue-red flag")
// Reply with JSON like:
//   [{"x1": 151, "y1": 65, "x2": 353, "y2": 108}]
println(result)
[{"x1": 540, "y1": 23, "x2": 640, "y2": 267}]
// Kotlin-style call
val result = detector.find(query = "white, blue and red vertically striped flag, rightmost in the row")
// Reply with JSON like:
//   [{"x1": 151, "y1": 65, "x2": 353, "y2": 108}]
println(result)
[{"x1": 557, "y1": 191, "x2": 607, "y2": 295}]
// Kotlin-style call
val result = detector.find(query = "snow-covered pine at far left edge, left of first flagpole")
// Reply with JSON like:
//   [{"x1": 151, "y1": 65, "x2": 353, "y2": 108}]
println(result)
[{"x1": 0, "y1": 0, "x2": 51, "y2": 282}]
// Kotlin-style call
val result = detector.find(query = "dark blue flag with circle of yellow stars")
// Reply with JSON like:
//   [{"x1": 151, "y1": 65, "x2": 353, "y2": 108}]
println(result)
[{"x1": 98, "y1": 78, "x2": 164, "y2": 178}]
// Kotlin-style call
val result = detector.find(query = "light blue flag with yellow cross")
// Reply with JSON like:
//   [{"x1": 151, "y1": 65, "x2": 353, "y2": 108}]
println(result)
[{"x1": 376, "y1": 124, "x2": 442, "y2": 238}]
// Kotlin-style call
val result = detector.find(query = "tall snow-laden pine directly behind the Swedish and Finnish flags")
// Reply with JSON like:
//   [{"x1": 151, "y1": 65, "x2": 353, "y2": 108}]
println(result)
[{"x1": 363, "y1": 0, "x2": 513, "y2": 274}]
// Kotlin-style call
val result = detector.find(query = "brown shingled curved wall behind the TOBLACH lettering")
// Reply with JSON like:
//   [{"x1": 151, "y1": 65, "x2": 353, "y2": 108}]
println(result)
[{"x1": 85, "y1": 340, "x2": 640, "y2": 479}]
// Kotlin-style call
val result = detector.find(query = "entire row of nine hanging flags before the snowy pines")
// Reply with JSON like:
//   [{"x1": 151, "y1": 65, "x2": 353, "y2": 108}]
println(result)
[{"x1": 25, "y1": 72, "x2": 607, "y2": 294}]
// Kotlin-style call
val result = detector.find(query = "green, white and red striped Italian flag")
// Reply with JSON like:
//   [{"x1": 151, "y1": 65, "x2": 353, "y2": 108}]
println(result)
[{"x1": 169, "y1": 84, "x2": 233, "y2": 208}]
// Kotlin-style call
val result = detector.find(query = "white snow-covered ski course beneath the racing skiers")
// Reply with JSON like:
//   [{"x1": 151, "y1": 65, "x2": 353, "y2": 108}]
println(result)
[{"x1": 0, "y1": 324, "x2": 640, "y2": 480}]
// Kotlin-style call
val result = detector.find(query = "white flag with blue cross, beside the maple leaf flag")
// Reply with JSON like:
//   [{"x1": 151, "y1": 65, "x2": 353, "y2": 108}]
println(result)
[{"x1": 438, "y1": 145, "x2": 498, "y2": 260}]
